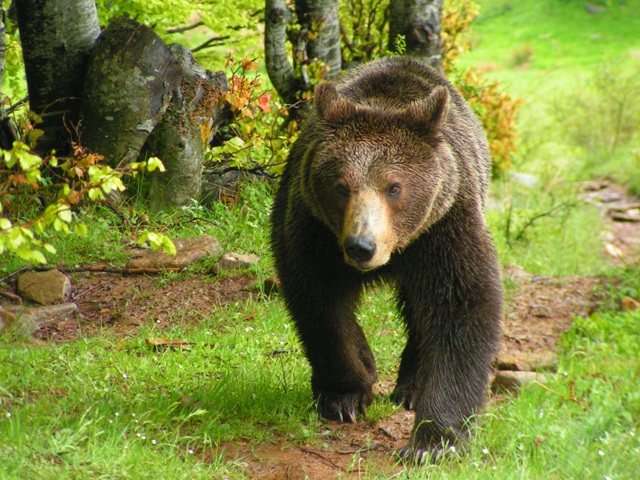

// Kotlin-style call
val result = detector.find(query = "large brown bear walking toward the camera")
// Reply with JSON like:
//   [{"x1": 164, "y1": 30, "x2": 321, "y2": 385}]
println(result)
[{"x1": 272, "y1": 57, "x2": 502, "y2": 461}]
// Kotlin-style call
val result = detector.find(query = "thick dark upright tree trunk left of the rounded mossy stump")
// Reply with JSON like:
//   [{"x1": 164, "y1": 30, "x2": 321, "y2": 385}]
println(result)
[{"x1": 15, "y1": 0, "x2": 100, "y2": 155}]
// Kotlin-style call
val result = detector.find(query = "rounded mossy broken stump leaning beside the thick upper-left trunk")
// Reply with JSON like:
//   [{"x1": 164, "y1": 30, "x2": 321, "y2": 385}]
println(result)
[{"x1": 81, "y1": 18, "x2": 180, "y2": 166}]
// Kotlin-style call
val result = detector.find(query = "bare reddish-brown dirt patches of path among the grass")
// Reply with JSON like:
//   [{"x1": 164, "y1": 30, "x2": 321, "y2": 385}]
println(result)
[{"x1": 26, "y1": 183, "x2": 640, "y2": 479}]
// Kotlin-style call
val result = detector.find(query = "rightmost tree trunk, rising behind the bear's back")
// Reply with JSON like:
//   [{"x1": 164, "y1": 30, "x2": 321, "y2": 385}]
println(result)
[{"x1": 389, "y1": 0, "x2": 442, "y2": 71}]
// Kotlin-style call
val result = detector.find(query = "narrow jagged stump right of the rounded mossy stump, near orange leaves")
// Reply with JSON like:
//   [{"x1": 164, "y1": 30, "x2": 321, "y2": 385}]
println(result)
[{"x1": 145, "y1": 45, "x2": 228, "y2": 211}]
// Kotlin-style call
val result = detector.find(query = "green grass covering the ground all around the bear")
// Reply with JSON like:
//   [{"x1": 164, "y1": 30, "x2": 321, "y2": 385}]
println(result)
[{"x1": 0, "y1": 0, "x2": 640, "y2": 479}]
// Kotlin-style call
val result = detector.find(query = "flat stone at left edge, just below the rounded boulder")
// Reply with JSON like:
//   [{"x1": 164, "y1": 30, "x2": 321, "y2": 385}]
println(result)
[{"x1": 0, "y1": 303, "x2": 82, "y2": 335}]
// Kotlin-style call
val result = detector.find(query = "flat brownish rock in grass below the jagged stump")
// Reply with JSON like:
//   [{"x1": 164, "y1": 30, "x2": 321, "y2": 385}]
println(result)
[{"x1": 126, "y1": 235, "x2": 220, "y2": 268}]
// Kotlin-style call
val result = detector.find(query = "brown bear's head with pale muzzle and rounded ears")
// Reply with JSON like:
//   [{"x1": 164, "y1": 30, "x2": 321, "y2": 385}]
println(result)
[{"x1": 301, "y1": 82, "x2": 458, "y2": 271}]
